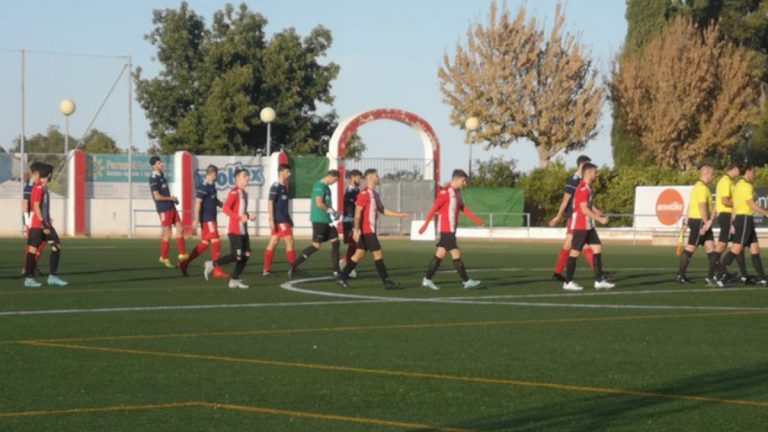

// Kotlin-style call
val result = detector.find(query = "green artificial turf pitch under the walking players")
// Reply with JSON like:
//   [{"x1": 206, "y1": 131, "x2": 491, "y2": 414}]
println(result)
[{"x1": 0, "y1": 238, "x2": 768, "y2": 431}]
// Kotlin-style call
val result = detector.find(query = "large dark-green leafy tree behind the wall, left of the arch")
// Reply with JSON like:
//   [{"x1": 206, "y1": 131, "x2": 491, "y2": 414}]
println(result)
[{"x1": 134, "y1": 2, "x2": 339, "y2": 154}]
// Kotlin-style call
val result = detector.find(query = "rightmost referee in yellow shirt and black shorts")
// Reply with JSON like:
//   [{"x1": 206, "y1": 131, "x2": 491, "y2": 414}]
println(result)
[{"x1": 717, "y1": 164, "x2": 768, "y2": 286}]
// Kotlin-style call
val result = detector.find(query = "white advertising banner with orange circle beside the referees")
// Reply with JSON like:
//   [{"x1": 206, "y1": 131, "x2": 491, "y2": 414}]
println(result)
[{"x1": 634, "y1": 186, "x2": 693, "y2": 228}]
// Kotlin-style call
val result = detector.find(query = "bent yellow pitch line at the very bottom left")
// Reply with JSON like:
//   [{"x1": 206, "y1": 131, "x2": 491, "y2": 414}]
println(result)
[{"x1": 0, "y1": 402, "x2": 474, "y2": 432}]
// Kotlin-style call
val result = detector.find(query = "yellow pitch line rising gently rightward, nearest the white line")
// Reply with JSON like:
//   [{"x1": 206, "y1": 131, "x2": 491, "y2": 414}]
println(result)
[{"x1": 12, "y1": 311, "x2": 768, "y2": 344}]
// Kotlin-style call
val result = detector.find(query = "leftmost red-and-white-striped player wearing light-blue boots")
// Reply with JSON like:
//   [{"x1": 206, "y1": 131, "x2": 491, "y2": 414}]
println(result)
[{"x1": 24, "y1": 164, "x2": 69, "y2": 288}]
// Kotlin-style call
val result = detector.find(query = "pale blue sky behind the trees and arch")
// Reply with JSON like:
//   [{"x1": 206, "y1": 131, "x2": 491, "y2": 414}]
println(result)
[{"x1": 0, "y1": 0, "x2": 626, "y2": 177}]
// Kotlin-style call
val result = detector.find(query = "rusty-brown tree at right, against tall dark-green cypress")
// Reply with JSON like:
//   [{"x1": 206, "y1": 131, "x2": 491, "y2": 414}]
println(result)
[{"x1": 612, "y1": 17, "x2": 759, "y2": 168}]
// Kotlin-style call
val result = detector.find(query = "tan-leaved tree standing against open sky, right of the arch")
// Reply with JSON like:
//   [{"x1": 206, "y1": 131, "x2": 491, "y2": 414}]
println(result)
[{"x1": 438, "y1": 2, "x2": 603, "y2": 167}]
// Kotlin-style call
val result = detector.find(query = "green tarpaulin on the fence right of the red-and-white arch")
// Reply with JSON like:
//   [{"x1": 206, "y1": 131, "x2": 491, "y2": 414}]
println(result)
[{"x1": 459, "y1": 188, "x2": 525, "y2": 227}]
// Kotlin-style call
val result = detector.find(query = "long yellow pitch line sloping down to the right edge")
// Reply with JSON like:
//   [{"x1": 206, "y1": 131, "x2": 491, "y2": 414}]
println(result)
[{"x1": 24, "y1": 342, "x2": 768, "y2": 408}]
